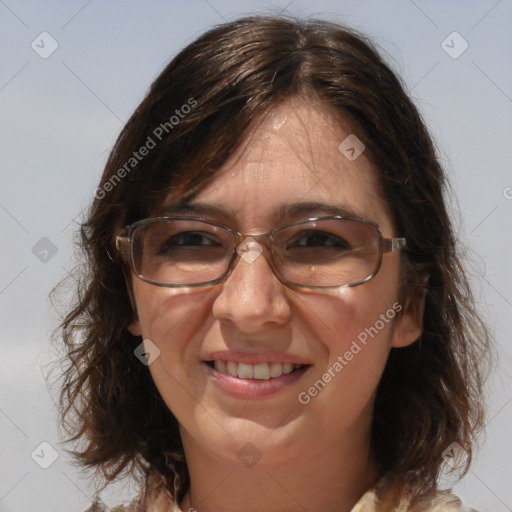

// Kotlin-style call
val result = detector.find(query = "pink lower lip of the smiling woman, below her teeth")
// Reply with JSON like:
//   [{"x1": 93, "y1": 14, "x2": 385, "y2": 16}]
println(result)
[{"x1": 203, "y1": 363, "x2": 310, "y2": 399}]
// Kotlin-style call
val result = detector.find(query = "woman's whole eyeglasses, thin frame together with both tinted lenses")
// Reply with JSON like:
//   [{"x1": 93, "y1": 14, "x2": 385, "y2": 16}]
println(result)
[{"x1": 116, "y1": 216, "x2": 405, "y2": 288}]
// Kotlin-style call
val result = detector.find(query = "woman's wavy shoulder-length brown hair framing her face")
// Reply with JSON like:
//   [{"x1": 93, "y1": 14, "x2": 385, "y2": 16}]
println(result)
[{"x1": 54, "y1": 16, "x2": 489, "y2": 510}]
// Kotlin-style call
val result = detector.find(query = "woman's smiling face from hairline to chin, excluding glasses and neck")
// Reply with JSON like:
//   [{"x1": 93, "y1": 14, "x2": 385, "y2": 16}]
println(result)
[{"x1": 130, "y1": 99, "x2": 420, "y2": 467}]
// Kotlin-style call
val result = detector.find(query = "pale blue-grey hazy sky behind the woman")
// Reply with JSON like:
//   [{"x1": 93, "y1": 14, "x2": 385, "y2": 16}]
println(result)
[{"x1": 0, "y1": 0, "x2": 512, "y2": 512}]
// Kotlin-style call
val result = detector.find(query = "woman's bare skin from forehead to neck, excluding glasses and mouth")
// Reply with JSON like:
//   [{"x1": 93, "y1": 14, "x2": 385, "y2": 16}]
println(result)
[{"x1": 130, "y1": 98, "x2": 421, "y2": 512}]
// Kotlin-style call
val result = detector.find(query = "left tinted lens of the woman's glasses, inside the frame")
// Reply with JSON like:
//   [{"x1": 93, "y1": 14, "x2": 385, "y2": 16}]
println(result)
[{"x1": 132, "y1": 219, "x2": 234, "y2": 285}]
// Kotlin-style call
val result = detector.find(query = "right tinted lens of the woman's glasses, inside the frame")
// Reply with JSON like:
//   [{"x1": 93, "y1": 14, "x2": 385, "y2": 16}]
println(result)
[{"x1": 274, "y1": 219, "x2": 380, "y2": 287}]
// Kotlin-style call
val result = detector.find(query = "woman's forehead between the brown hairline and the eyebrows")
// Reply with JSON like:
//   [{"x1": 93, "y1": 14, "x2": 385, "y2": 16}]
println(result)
[{"x1": 164, "y1": 97, "x2": 389, "y2": 229}]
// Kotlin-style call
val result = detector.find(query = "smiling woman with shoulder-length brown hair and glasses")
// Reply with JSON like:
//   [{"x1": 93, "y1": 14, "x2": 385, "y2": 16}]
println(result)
[{"x1": 57, "y1": 17, "x2": 489, "y2": 512}]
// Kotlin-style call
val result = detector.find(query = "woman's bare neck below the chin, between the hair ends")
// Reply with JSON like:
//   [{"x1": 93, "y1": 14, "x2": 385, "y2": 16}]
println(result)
[{"x1": 180, "y1": 424, "x2": 377, "y2": 512}]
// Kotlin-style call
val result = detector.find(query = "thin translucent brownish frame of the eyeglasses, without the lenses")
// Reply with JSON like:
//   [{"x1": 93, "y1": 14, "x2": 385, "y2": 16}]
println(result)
[{"x1": 115, "y1": 215, "x2": 406, "y2": 289}]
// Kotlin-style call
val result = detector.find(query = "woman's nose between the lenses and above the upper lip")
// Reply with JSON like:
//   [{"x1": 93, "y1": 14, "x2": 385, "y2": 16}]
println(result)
[{"x1": 213, "y1": 239, "x2": 291, "y2": 334}]
